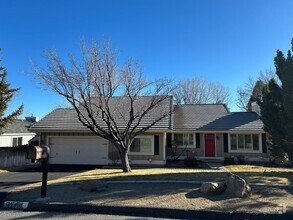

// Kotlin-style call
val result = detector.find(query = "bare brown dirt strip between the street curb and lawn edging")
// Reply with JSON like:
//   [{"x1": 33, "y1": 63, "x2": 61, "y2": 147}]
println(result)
[{"x1": 6, "y1": 183, "x2": 293, "y2": 213}]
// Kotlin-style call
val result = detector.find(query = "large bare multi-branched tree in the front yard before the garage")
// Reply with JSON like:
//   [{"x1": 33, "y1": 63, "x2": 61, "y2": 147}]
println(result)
[{"x1": 33, "y1": 42, "x2": 172, "y2": 172}]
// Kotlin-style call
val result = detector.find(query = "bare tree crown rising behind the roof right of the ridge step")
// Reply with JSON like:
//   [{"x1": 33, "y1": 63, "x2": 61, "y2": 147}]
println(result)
[{"x1": 173, "y1": 78, "x2": 230, "y2": 104}]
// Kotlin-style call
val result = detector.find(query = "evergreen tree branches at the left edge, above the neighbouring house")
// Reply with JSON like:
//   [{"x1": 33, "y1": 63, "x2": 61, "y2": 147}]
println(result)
[{"x1": 0, "y1": 49, "x2": 23, "y2": 133}]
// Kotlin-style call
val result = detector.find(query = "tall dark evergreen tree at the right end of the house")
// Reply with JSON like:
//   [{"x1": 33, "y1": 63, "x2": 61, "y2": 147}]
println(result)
[{"x1": 259, "y1": 39, "x2": 293, "y2": 160}]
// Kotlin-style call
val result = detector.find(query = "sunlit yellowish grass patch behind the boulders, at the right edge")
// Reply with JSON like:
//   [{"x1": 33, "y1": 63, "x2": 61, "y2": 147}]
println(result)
[{"x1": 225, "y1": 165, "x2": 293, "y2": 184}]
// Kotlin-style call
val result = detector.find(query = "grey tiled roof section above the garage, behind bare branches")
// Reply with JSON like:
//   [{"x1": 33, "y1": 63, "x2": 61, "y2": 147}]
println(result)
[{"x1": 30, "y1": 96, "x2": 172, "y2": 132}]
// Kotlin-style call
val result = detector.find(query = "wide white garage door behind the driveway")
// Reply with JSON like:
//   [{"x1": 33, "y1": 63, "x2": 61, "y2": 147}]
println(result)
[{"x1": 49, "y1": 137, "x2": 108, "y2": 165}]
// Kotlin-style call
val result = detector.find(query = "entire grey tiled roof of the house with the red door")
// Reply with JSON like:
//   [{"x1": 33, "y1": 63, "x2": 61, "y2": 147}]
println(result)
[{"x1": 30, "y1": 100, "x2": 263, "y2": 132}]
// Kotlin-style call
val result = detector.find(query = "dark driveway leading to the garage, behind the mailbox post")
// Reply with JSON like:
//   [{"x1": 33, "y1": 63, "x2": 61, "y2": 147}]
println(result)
[{"x1": 0, "y1": 165, "x2": 96, "y2": 207}]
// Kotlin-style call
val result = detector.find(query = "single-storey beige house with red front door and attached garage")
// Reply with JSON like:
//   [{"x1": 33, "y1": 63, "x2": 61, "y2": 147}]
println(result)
[{"x1": 30, "y1": 98, "x2": 268, "y2": 165}]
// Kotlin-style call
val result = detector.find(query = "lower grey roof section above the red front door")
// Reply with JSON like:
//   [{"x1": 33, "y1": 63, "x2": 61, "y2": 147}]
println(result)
[{"x1": 173, "y1": 105, "x2": 263, "y2": 131}]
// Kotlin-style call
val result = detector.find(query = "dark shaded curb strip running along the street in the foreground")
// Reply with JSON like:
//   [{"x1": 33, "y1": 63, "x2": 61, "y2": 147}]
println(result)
[{"x1": 5, "y1": 201, "x2": 293, "y2": 220}]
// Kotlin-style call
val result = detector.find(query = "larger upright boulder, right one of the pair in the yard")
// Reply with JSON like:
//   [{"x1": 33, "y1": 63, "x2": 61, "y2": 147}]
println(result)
[{"x1": 225, "y1": 173, "x2": 251, "y2": 198}]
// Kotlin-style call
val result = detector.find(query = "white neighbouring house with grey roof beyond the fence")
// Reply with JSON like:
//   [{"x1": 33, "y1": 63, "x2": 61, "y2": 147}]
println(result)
[{"x1": 0, "y1": 117, "x2": 36, "y2": 147}]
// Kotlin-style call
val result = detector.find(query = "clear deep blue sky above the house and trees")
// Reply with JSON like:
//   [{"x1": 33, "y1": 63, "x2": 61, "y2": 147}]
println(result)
[{"x1": 0, "y1": 0, "x2": 293, "y2": 117}]
